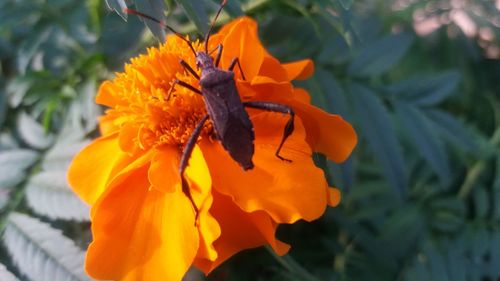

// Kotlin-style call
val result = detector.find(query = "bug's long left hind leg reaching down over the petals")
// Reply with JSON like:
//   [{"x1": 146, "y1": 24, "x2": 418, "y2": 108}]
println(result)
[{"x1": 179, "y1": 114, "x2": 208, "y2": 226}]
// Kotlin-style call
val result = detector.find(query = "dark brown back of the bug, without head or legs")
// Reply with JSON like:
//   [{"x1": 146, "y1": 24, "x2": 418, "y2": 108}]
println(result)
[{"x1": 202, "y1": 71, "x2": 255, "y2": 170}]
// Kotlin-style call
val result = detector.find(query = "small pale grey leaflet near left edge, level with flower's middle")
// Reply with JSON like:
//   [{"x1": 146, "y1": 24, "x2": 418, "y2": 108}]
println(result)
[{"x1": 17, "y1": 112, "x2": 54, "y2": 149}]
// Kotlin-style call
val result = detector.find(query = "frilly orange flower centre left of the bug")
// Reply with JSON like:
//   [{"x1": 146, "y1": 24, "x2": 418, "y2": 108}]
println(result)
[{"x1": 107, "y1": 36, "x2": 213, "y2": 149}]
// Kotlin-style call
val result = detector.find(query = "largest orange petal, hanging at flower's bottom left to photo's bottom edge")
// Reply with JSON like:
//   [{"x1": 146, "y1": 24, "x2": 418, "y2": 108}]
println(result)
[{"x1": 86, "y1": 165, "x2": 203, "y2": 281}]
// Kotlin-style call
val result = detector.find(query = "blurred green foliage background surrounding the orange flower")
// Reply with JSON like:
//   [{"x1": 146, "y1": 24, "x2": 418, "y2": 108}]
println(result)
[{"x1": 0, "y1": 0, "x2": 500, "y2": 281}]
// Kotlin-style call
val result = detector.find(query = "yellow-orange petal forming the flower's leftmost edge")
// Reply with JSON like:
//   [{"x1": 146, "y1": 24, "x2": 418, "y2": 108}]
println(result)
[{"x1": 68, "y1": 134, "x2": 134, "y2": 205}]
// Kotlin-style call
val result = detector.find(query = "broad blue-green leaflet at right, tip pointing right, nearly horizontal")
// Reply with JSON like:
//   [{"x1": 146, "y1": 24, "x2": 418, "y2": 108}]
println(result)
[{"x1": 388, "y1": 71, "x2": 461, "y2": 106}]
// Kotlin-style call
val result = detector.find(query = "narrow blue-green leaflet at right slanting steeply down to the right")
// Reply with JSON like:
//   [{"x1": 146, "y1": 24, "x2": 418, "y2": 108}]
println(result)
[{"x1": 394, "y1": 102, "x2": 451, "y2": 185}]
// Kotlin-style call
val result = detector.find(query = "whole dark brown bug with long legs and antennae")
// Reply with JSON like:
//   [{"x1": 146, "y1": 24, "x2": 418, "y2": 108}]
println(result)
[{"x1": 125, "y1": 0, "x2": 295, "y2": 223}]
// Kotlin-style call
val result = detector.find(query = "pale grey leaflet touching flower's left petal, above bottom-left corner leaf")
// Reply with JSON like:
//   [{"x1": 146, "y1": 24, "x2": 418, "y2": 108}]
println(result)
[{"x1": 26, "y1": 170, "x2": 89, "y2": 221}]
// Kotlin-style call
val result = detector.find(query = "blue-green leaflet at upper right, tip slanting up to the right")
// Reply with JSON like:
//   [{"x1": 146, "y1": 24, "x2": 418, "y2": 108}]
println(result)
[{"x1": 347, "y1": 33, "x2": 413, "y2": 77}]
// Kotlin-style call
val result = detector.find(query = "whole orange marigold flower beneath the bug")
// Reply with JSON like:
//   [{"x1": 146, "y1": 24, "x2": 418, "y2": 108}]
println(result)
[{"x1": 69, "y1": 17, "x2": 357, "y2": 280}]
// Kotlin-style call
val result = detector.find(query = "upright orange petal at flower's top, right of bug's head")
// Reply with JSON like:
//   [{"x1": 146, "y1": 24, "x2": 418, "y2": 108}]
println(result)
[{"x1": 221, "y1": 17, "x2": 264, "y2": 81}]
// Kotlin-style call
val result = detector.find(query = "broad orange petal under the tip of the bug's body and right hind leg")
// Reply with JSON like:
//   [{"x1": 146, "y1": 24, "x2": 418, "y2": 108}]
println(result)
[{"x1": 202, "y1": 113, "x2": 328, "y2": 223}]
